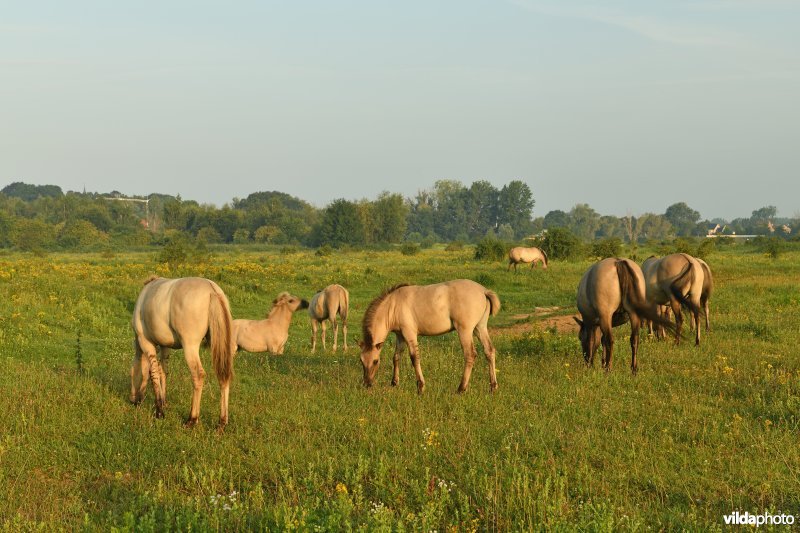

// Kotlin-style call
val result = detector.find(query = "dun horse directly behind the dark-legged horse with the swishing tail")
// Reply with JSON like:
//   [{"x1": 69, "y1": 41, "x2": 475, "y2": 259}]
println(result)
[{"x1": 645, "y1": 253, "x2": 710, "y2": 346}]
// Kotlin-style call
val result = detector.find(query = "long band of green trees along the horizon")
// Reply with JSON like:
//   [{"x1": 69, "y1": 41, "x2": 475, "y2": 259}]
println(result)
[{"x1": 0, "y1": 180, "x2": 800, "y2": 250}]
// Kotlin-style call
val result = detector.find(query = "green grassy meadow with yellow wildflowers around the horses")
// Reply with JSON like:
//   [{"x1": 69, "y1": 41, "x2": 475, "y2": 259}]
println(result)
[{"x1": 0, "y1": 247, "x2": 800, "y2": 531}]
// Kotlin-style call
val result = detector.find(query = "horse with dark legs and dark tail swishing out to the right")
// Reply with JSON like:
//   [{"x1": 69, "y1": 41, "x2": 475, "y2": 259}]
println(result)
[{"x1": 573, "y1": 257, "x2": 673, "y2": 374}]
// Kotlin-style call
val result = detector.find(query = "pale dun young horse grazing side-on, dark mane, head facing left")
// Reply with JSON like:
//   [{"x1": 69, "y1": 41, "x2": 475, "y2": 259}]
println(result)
[{"x1": 359, "y1": 279, "x2": 500, "y2": 394}]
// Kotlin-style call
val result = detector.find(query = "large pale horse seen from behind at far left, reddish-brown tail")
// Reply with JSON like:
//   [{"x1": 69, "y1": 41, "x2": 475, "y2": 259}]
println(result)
[{"x1": 130, "y1": 276, "x2": 234, "y2": 430}]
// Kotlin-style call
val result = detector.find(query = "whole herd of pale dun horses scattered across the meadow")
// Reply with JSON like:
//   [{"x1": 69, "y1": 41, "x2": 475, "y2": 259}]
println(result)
[{"x1": 130, "y1": 247, "x2": 714, "y2": 430}]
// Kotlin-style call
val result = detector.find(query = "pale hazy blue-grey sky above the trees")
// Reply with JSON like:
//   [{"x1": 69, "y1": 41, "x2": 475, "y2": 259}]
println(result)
[{"x1": 0, "y1": 0, "x2": 800, "y2": 218}]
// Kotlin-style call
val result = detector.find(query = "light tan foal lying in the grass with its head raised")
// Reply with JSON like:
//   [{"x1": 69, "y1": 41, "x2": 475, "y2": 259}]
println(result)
[{"x1": 233, "y1": 292, "x2": 308, "y2": 355}]
